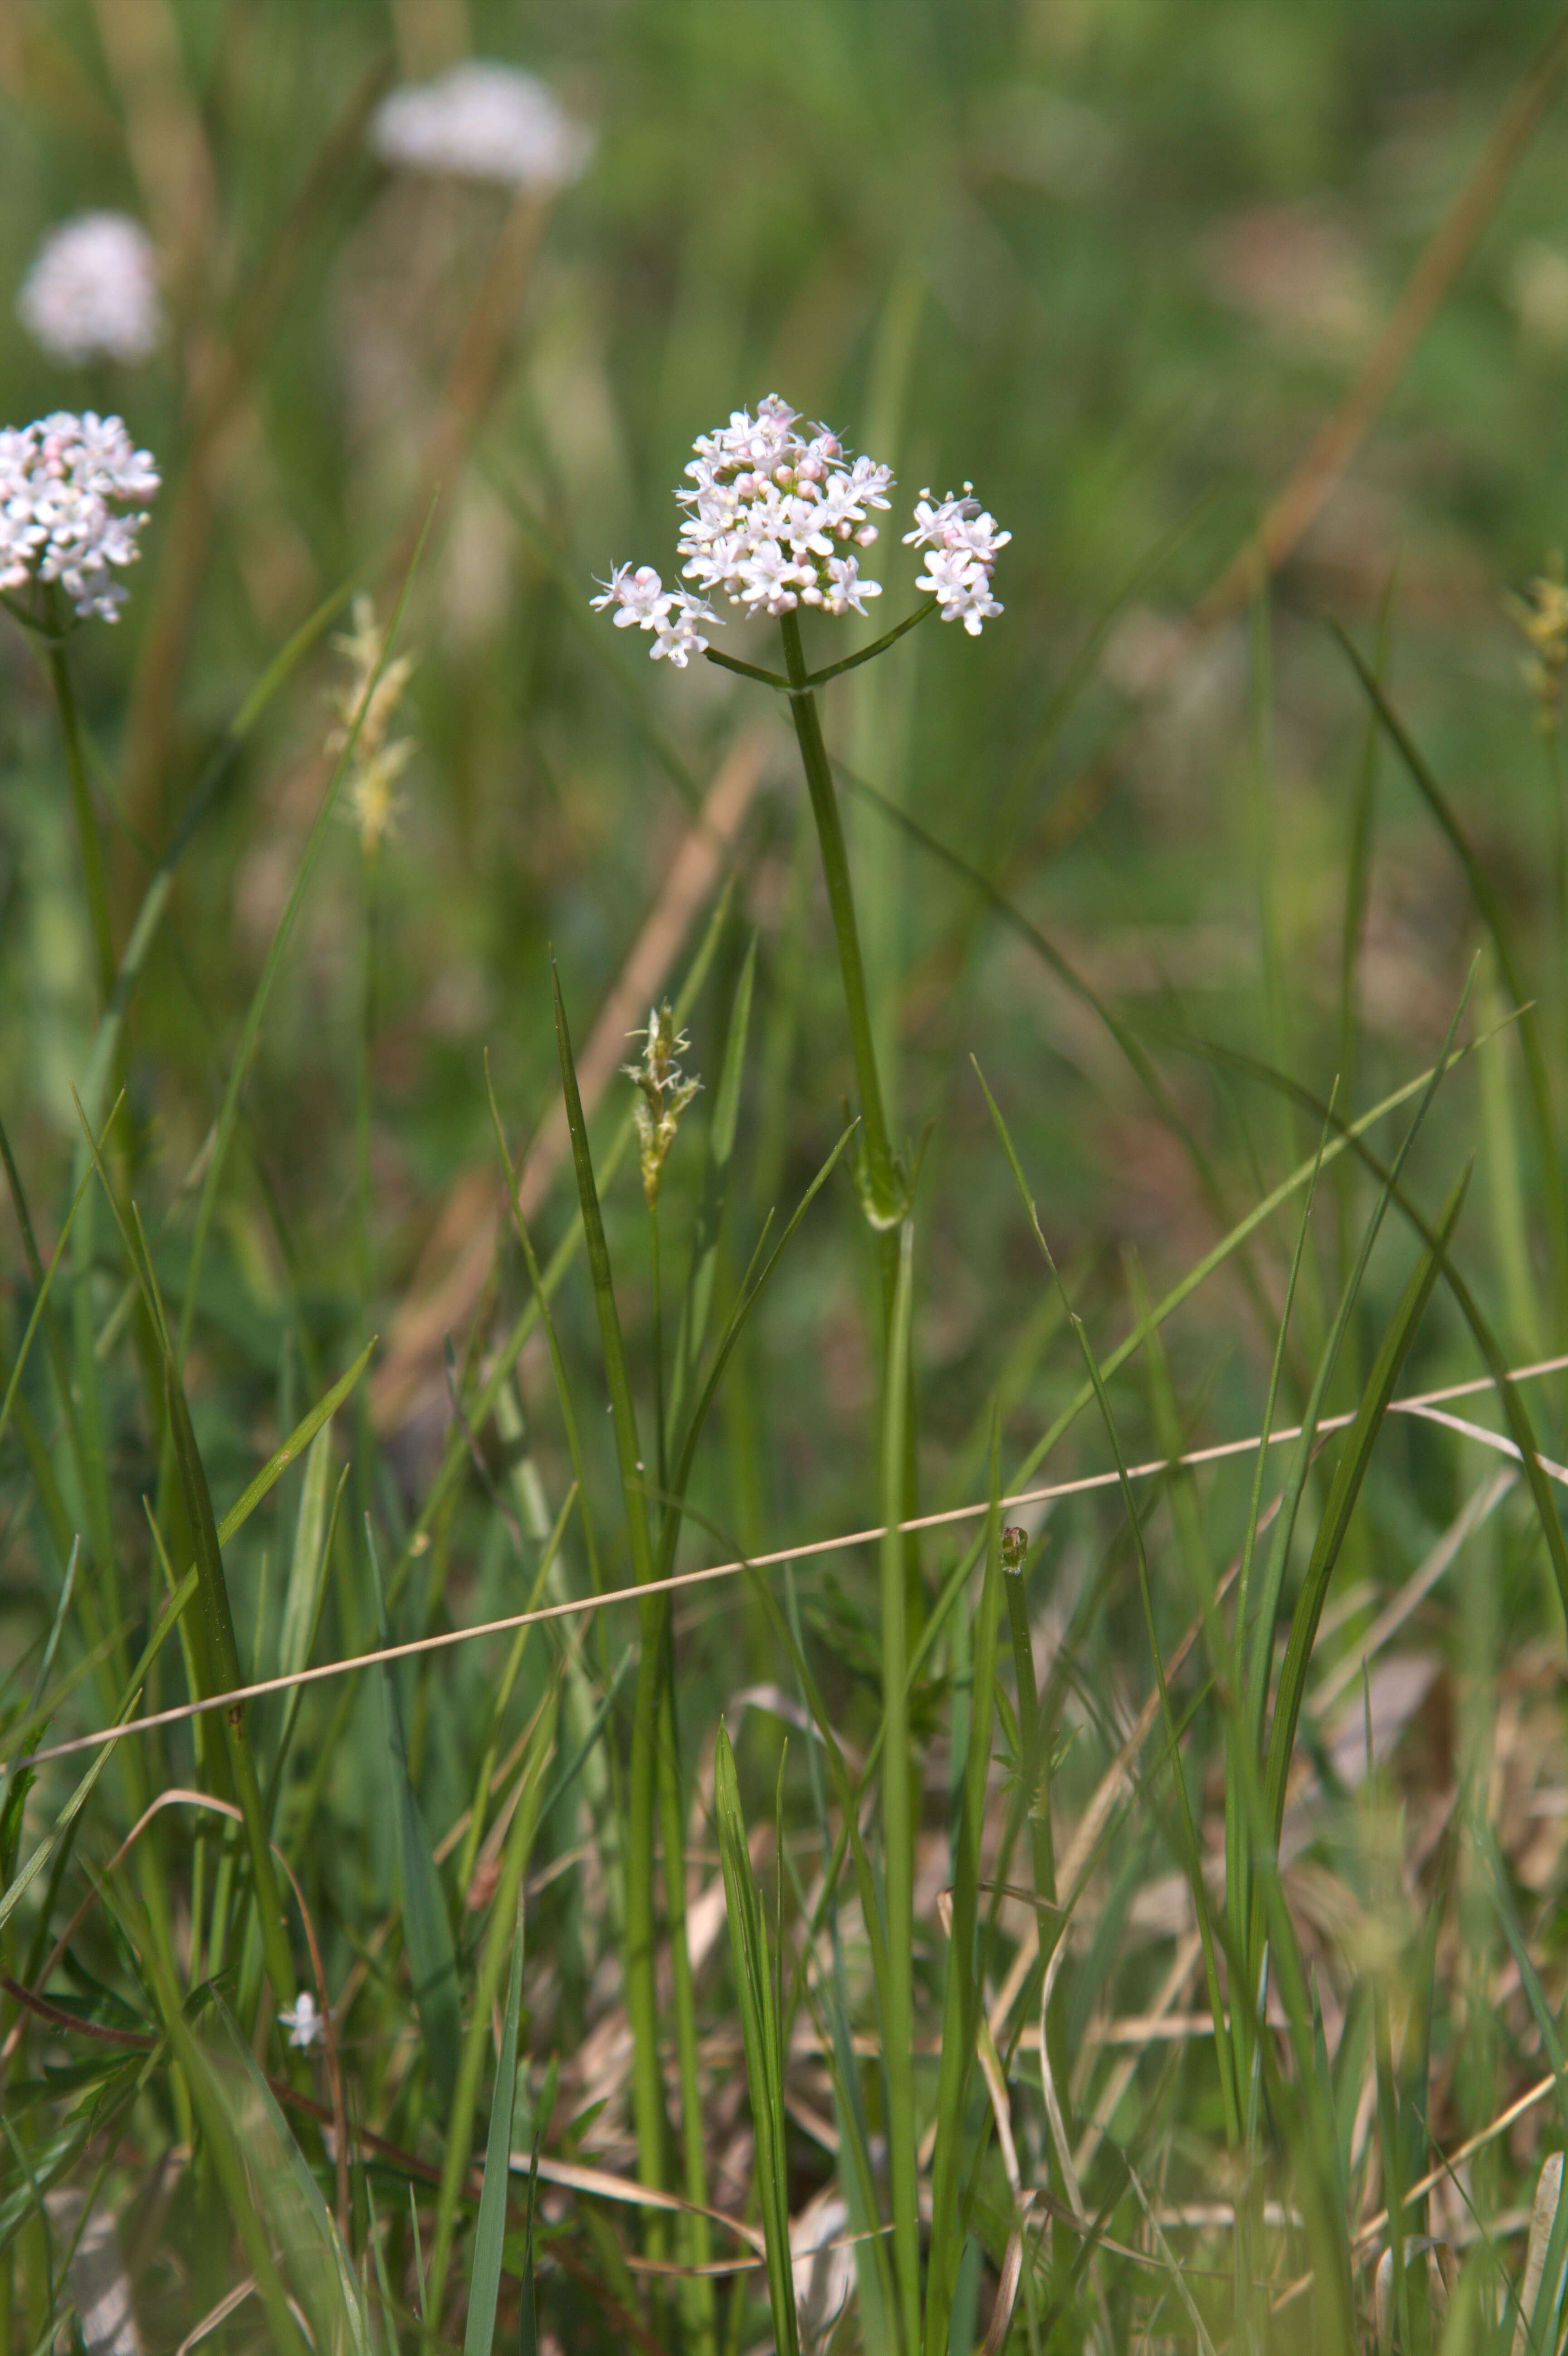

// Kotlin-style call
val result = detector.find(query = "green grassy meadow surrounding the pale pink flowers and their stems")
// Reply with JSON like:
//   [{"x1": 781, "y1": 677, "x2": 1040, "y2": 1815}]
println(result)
[{"x1": 0, "y1": 0, "x2": 1568, "y2": 2356}]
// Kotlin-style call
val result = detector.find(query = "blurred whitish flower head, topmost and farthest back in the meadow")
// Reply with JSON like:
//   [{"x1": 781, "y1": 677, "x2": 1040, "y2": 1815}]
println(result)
[{"x1": 370, "y1": 59, "x2": 593, "y2": 189}]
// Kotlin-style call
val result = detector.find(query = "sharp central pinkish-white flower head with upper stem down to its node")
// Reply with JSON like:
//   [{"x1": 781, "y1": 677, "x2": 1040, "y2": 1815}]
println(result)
[{"x1": 591, "y1": 393, "x2": 1012, "y2": 1234}]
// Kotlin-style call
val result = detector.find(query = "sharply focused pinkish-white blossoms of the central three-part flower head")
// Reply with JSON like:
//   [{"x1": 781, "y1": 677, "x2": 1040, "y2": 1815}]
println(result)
[{"x1": 593, "y1": 393, "x2": 1012, "y2": 667}]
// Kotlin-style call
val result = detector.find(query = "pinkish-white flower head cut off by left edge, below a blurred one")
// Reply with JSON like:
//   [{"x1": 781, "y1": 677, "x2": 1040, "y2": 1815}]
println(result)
[{"x1": 0, "y1": 410, "x2": 158, "y2": 622}]
